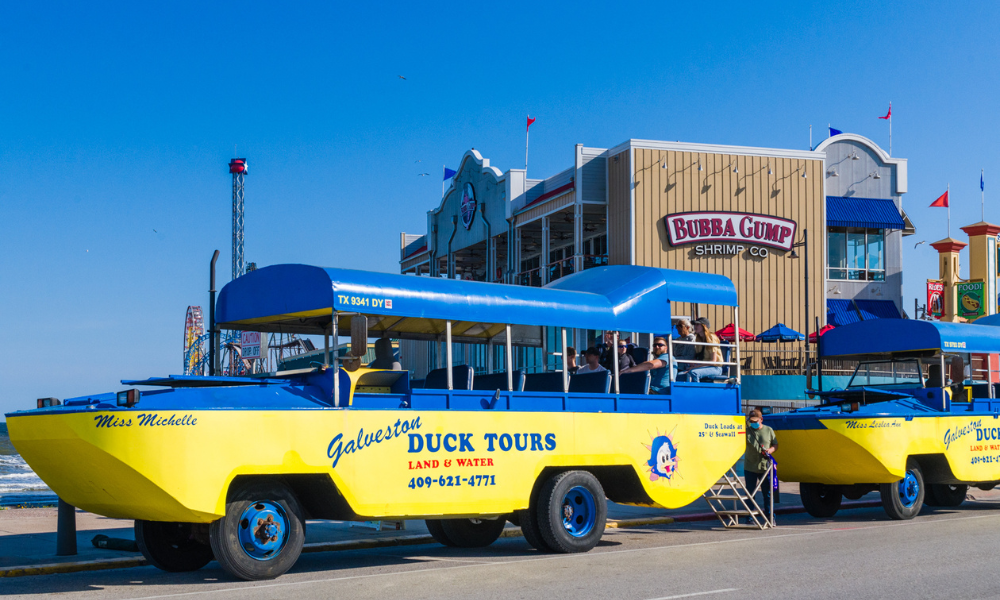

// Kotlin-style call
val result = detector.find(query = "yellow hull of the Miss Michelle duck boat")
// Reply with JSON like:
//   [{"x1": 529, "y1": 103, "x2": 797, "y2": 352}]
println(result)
[{"x1": 7, "y1": 409, "x2": 744, "y2": 522}]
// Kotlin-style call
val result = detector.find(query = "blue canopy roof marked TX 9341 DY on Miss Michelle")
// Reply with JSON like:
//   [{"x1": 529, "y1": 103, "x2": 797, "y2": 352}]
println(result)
[{"x1": 217, "y1": 265, "x2": 736, "y2": 338}]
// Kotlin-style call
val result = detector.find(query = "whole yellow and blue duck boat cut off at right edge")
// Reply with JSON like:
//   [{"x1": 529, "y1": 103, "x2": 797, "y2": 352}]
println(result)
[{"x1": 768, "y1": 319, "x2": 1000, "y2": 519}]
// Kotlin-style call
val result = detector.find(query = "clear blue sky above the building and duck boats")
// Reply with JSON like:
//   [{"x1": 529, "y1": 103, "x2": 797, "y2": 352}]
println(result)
[{"x1": 0, "y1": 1, "x2": 1000, "y2": 412}]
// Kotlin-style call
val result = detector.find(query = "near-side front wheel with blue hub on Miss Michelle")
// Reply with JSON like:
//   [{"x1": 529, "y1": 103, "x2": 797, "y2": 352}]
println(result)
[{"x1": 209, "y1": 480, "x2": 305, "y2": 581}]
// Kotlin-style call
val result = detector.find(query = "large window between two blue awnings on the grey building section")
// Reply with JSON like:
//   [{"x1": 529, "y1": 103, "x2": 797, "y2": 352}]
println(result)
[{"x1": 826, "y1": 227, "x2": 885, "y2": 281}]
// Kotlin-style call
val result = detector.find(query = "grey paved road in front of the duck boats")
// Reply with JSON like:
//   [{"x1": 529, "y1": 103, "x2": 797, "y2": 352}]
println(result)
[{"x1": 0, "y1": 503, "x2": 1000, "y2": 600}]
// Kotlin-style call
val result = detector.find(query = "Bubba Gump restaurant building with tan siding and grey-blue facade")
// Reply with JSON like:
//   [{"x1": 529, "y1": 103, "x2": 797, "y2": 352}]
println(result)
[{"x1": 400, "y1": 134, "x2": 912, "y2": 377}]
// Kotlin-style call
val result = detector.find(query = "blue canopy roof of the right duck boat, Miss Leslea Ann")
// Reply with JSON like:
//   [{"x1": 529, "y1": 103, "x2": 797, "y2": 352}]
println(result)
[{"x1": 820, "y1": 319, "x2": 1000, "y2": 357}]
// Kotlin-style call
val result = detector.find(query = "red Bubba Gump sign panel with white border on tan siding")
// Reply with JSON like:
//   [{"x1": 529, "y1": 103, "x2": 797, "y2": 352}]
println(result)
[{"x1": 663, "y1": 212, "x2": 797, "y2": 251}]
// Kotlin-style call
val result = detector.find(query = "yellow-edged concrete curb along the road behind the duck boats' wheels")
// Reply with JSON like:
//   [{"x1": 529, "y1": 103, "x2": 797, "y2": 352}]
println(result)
[{"x1": 0, "y1": 500, "x2": 882, "y2": 578}]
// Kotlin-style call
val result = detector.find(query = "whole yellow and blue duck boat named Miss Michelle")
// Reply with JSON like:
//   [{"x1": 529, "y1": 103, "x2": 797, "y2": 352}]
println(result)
[{"x1": 7, "y1": 265, "x2": 744, "y2": 579}]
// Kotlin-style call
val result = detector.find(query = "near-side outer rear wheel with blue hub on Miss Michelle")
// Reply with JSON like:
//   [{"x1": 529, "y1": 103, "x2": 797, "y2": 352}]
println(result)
[{"x1": 534, "y1": 471, "x2": 608, "y2": 553}]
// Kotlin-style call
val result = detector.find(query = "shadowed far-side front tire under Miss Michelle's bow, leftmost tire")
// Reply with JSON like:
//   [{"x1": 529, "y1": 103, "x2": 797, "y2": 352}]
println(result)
[{"x1": 134, "y1": 521, "x2": 212, "y2": 573}]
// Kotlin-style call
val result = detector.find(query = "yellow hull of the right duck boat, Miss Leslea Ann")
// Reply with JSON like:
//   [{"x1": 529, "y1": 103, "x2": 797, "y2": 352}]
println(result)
[{"x1": 774, "y1": 415, "x2": 1000, "y2": 485}]
